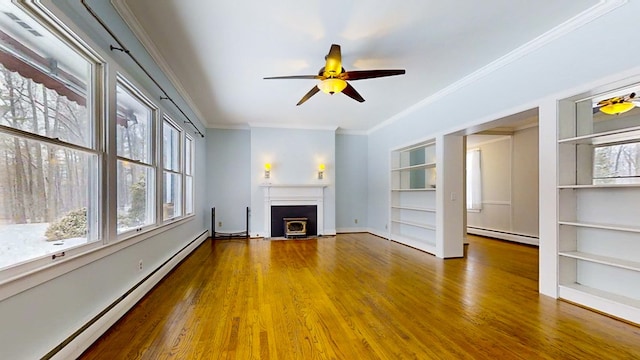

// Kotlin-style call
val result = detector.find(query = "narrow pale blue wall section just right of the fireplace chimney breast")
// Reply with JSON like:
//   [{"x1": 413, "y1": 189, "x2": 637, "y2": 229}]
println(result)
[{"x1": 336, "y1": 134, "x2": 368, "y2": 232}]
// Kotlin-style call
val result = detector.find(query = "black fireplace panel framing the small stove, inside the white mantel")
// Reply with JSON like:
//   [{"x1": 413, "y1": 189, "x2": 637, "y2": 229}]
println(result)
[{"x1": 271, "y1": 205, "x2": 318, "y2": 237}]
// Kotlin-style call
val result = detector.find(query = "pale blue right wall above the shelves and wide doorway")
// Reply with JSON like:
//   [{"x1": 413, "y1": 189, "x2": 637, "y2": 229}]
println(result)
[{"x1": 368, "y1": 1, "x2": 640, "y2": 232}]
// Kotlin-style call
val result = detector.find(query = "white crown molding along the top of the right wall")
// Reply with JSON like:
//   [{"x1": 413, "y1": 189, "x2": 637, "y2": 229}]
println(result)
[{"x1": 367, "y1": 0, "x2": 629, "y2": 135}]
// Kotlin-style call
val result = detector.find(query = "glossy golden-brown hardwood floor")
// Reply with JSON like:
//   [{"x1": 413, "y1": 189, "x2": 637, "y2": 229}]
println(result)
[{"x1": 81, "y1": 234, "x2": 640, "y2": 360}]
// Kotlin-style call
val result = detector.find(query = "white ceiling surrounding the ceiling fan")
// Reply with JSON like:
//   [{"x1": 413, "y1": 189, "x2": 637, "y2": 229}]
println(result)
[{"x1": 113, "y1": 0, "x2": 598, "y2": 132}]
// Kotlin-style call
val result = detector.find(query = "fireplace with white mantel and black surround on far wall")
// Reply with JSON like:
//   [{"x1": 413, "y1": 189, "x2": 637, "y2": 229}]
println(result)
[{"x1": 263, "y1": 184, "x2": 326, "y2": 238}]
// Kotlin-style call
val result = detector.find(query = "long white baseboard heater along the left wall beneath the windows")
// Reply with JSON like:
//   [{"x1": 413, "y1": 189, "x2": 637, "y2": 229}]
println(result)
[{"x1": 42, "y1": 231, "x2": 208, "y2": 359}]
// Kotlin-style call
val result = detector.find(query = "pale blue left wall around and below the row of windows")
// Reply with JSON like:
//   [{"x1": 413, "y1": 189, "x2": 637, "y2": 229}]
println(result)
[{"x1": 0, "y1": 0, "x2": 209, "y2": 359}]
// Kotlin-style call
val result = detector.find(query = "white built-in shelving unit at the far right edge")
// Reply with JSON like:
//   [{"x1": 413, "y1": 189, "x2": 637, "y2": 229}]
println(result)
[{"x1": 557, "y1": 88, "x2": 640, "y2": 324}]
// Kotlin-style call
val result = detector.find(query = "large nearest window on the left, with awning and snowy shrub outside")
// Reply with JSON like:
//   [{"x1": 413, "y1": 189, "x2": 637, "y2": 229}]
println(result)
[{"x1": 0, "y1": 4, "x2": 102, "y2": 268}]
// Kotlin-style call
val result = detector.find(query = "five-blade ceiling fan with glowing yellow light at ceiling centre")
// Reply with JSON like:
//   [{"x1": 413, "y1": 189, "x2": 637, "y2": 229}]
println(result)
[{"x1": 265, "y1": 44, "x2": 405, "y2": 106}]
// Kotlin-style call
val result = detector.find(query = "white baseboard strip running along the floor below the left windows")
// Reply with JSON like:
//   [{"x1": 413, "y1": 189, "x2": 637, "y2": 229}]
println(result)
[{"x1": 51, "y1": 231, "x2": 209, "y2": 359}]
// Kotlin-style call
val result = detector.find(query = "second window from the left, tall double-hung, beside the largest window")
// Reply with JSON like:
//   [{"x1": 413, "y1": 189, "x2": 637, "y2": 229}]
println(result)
[{"x1": 116, "y1": 78, "x2": 155, "y2": 234}]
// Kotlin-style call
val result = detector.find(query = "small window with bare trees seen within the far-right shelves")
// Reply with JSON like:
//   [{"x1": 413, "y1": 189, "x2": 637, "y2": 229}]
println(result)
[{"x1": 593, "y1": 142, "x2": 640, "y2": 184}]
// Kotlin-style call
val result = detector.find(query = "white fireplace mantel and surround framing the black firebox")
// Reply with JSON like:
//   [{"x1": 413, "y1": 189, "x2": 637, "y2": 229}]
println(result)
[{"x1": 261, "y1": 183, "x2": 329, "y2": 238}]
